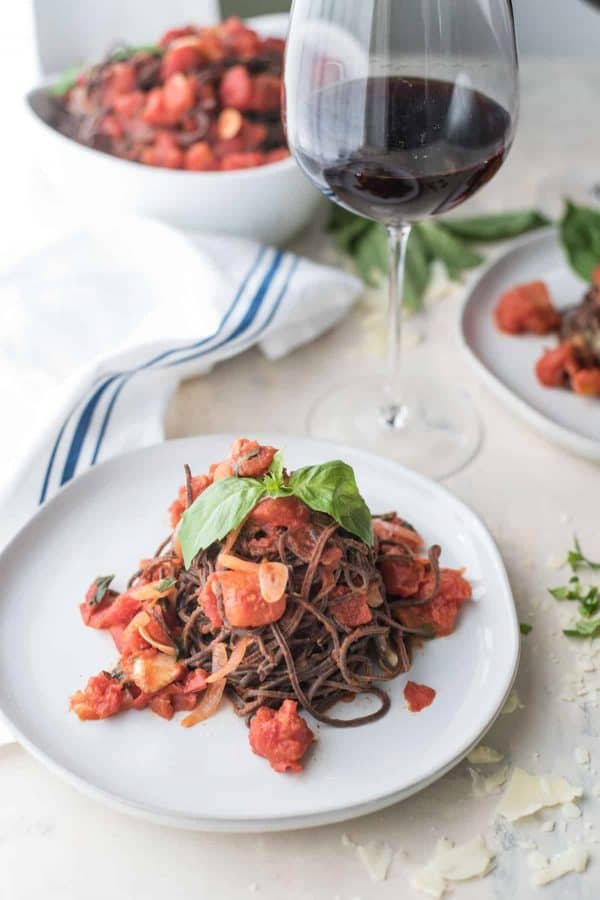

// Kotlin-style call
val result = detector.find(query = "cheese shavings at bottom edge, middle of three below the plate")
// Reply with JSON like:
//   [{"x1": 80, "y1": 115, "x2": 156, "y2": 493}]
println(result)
[{"x1": 413, "y1": 835, "x2": 494, "y2": 898}]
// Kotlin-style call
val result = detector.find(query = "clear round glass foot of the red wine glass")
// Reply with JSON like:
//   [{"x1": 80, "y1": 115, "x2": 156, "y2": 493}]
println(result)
[{"x1": 307, "y1": 376, "x2": 481, "y2": 480}]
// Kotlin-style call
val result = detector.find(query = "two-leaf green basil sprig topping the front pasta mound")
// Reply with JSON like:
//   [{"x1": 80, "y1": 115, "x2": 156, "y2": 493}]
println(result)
[{"x1": 178, "y1": 453, "x2": 373, "y2": 568}]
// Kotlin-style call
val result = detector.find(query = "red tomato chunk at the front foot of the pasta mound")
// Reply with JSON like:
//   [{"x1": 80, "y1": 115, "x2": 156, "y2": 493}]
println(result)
[{"x1": 249, "y1": 700, "x2": 314, "y2": 772}]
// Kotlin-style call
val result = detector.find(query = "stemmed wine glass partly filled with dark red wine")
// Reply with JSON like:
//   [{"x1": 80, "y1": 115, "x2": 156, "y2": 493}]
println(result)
[{"x1": 284, "y1": 0, "x2": 518, "y2": 478}]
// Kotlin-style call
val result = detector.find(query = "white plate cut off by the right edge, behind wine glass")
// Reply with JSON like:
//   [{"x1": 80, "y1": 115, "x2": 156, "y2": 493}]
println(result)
[{"x1": 461, "y1": 229, "x2": 600, "y2": 462}]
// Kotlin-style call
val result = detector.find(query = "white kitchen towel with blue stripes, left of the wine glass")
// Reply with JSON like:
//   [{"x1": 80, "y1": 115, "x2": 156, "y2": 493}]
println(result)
[{"x1": 0, "y1": 217, "x2": 361, "y2": 544}]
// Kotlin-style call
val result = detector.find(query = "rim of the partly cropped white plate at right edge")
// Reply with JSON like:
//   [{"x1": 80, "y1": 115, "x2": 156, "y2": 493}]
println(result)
[{"x1": 457, "y1": 226, "x2": 600, "y2": 463}]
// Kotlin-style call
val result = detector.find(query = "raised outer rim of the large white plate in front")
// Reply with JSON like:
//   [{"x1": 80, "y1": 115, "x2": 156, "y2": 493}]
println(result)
[{"x1": 0, "y1": 431, "x2": 521, "y2": 833}]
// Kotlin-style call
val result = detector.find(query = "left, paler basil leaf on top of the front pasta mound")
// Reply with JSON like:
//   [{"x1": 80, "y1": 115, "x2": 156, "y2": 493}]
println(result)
[{"x1": 178, "y1": 476, "x2": 266, "y2": 568}]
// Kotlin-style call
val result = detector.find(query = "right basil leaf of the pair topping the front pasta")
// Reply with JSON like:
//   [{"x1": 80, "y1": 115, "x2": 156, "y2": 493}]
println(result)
[{"x1": 288, "y1": 460, "x2": 373, "y2": 546}]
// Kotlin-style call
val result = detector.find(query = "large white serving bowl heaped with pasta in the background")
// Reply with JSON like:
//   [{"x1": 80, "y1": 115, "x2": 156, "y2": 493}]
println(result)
[{"x1": 25, "y1": 15, "x2": 321, "y2": 244}]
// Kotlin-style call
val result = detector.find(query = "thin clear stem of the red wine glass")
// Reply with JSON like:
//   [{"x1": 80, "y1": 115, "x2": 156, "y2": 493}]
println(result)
[{"x1": 381, "y1": 225, "x2": 411, "y2": 428}]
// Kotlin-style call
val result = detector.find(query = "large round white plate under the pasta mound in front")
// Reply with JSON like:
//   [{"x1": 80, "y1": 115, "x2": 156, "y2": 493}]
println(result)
[{"x1": 0, "y1": 434, "x2": 519, "y2": 831}]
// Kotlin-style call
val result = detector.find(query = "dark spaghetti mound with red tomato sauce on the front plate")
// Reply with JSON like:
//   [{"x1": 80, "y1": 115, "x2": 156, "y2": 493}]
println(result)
[{"x1": 72, "y1": 441, "x2": 470, "y2": 771}]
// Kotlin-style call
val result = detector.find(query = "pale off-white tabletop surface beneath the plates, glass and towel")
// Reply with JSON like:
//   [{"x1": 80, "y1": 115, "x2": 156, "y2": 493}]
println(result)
[{"x1": 0, "y1": 62, "x2": 600, "y2": 900}]
